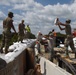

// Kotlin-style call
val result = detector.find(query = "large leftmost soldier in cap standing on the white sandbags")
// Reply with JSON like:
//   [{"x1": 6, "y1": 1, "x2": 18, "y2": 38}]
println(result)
[{"x1": 0, "y1": 12, "x2": 16, "y2": 54}]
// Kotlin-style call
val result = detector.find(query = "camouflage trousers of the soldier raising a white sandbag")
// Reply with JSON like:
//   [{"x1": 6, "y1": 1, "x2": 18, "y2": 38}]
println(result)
[{"x1": 64, "y1": 35, "x2": 75, "y2": 55}]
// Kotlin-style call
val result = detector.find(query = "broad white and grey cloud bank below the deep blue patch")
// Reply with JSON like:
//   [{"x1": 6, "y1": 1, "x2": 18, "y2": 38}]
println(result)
[{"x1": 0, "y1": 0, "x2": 76, "y2": 34}]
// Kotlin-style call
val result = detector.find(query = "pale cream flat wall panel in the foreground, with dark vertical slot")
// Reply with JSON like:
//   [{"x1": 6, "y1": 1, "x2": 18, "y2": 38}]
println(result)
[{"x1": 40, "y1": 57, "x2": 72, "y2": 75}]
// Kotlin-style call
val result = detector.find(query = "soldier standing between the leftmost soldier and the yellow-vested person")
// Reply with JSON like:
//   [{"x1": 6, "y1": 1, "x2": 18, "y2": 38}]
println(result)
[{"x1": 18, "y1": 20, "x2": 25, "y2": 43}]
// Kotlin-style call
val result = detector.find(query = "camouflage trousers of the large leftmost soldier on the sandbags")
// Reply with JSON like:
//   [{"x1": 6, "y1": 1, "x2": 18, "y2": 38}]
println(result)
[{"x1": 1, "y1": 32, "x2": 11, "y2": 54}]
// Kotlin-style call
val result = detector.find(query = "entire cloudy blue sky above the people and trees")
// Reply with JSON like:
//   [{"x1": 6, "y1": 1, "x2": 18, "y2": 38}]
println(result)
[{"x1": 0, "y1": 0, "x2": 76, "y2": 34}]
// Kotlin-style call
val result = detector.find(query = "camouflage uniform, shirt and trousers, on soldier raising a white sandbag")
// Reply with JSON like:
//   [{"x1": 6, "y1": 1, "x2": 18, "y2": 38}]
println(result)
[{"x1": 64, "y1": 25, "x2": 75, "y2": 55}]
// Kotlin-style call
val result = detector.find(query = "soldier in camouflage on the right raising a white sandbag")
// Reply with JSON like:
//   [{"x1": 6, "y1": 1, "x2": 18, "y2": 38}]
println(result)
[{"x1": 58, "y1": 19, "x2": 76, "y2": 57}]
